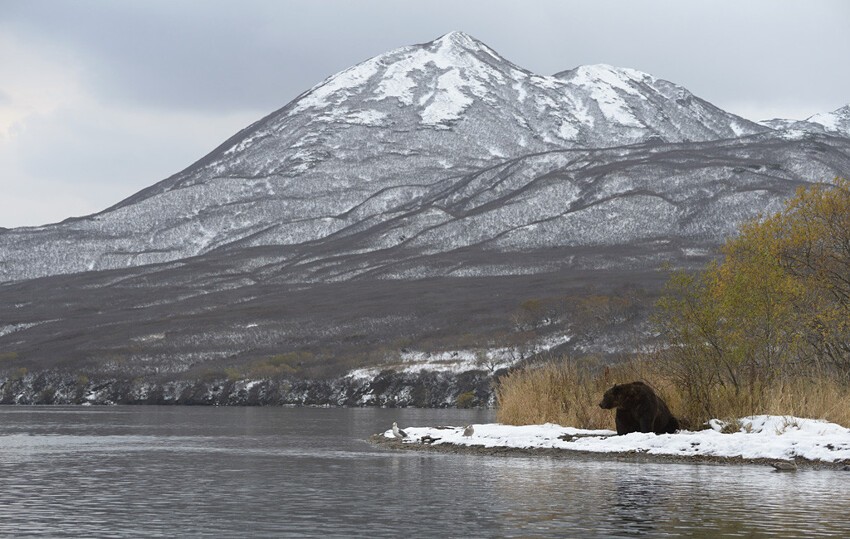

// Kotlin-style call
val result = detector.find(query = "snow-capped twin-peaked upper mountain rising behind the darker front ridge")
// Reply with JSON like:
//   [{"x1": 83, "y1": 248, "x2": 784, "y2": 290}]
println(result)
[{"x1": 0, "y1": 32, "x2": 767, "y2": 281}]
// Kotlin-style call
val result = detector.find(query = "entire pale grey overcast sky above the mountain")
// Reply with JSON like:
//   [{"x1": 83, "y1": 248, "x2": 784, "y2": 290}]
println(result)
[{"x1": 0, "y1": 0, "x2": 850, "y2": 227}]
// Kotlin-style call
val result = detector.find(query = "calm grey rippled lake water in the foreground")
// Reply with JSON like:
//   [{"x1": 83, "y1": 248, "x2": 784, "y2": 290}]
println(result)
[{"x1": 0, "y1": 406, "x2": 850, "y2": 538}]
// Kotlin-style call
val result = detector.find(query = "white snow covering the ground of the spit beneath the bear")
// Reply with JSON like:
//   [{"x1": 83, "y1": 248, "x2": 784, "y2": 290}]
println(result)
[{"x1": 384, "y1": 415, "x2": 850, "y2": 462}]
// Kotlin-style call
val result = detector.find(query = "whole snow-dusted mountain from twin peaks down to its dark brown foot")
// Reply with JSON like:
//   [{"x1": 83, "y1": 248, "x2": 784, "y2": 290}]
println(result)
[{"x1": 0, "y1": 32, "x2": 850, "y2": 402}]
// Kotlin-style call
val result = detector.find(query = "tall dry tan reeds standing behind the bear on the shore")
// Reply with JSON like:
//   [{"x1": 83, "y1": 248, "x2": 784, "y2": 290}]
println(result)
[{"x1": 496, "y1": 359, "x2": 850, "y2": 429}]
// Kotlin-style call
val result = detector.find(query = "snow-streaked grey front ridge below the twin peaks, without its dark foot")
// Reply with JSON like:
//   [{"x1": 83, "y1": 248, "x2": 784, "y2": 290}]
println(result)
[{"x1": 232, "y1": 134, "x2": 850, "y2": 281}]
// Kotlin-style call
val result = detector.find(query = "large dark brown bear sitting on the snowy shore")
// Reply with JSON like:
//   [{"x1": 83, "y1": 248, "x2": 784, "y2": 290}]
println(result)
[{"x1": 599, "y1": 382, "x2": 679, "y2": 434}]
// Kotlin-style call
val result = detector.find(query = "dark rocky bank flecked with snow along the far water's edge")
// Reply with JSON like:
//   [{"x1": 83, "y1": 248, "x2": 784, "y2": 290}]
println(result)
[{"x1": 0, "y1": 371, "x2": 494, "y2": 408}]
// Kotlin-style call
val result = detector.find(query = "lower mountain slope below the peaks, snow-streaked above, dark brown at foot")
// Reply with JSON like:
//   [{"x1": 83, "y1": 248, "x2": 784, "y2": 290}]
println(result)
[{"x1": 0, "y1": 135, "x2": 850, "y2": 386}]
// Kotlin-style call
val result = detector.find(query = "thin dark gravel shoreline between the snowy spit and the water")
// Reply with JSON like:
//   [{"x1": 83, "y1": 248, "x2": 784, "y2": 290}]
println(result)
[{"x1": 367, "y1": 434, "x2": 850, "y2": 471}]
